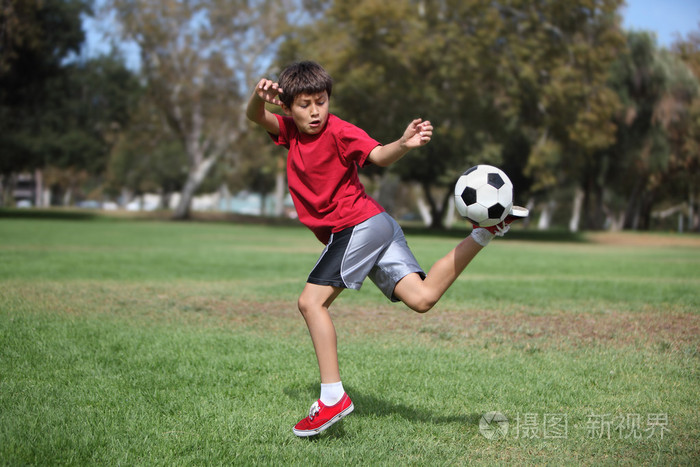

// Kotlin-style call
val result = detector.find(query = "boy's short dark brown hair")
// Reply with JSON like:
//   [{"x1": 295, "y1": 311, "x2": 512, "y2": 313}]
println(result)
[{"x1": 278, "y1": 61, "x2": 333, "y2": 108}]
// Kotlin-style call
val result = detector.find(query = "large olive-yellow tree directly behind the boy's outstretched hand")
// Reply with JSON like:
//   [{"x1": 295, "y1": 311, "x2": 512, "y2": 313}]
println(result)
[{"x1": 280, "y1": 0, "x2": 516, "y2": 227}]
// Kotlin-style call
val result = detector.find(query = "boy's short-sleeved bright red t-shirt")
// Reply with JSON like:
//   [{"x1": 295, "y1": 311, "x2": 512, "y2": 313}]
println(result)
[{"x1": 271, "y1": 114, "x2": 384, "y2": 244}]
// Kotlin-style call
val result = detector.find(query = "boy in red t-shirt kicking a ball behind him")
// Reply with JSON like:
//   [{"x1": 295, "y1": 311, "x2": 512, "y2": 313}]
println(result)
[{"x1": 246, "y1": 62, "x2": 527, "y2": 436}]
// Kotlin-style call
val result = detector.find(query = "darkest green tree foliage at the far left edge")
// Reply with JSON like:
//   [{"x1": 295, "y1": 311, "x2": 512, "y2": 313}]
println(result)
[{"x1": 0, "y1": 0, "x2": 139, "y2": 201}]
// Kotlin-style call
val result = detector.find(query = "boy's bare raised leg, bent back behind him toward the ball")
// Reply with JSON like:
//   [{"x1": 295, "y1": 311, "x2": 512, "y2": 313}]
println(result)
[{"x1": 394, "y1": 236, "x2": 483, "y2": 313}]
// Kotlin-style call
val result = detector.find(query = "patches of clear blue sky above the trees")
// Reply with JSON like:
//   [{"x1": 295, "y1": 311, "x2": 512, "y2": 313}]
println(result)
[{"x1": 83, "y1": 0, "x2": 700, "y2": 69}]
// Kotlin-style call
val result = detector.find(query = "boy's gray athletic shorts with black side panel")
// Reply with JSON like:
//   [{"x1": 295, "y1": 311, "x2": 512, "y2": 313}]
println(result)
[{"x1": 307, "y1": 212, "x2": 425, "y2": 302}]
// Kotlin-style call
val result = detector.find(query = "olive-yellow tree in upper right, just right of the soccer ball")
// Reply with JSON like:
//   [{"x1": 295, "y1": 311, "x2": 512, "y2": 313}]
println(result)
[{"x1": 495, "y1": 0, "x2": 624, "y2": 230}]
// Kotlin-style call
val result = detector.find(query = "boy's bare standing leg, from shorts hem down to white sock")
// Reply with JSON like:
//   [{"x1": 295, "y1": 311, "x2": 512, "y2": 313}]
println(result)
[{"x1": 299, "y1": 283, "x2": 343, "y2": 384}]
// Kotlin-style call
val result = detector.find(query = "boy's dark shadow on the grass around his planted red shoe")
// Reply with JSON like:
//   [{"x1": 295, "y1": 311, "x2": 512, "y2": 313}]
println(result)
[{"x1": 284, "y1": 384, "x2": 482, "y2": 439}]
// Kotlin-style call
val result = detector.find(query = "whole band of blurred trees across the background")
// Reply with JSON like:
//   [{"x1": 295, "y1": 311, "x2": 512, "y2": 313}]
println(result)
[{"x1": 0, "y1": 0, "x2": 700, "y2": 230}]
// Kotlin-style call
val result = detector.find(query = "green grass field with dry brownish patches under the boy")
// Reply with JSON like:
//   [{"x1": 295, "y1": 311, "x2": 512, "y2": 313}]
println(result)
[{"x1": 0, "y1": 216, "x2": 700, "y2": 465}]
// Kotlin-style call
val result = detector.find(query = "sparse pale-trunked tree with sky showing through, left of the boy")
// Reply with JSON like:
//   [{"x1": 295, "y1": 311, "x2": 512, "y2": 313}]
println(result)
[{"x1": 108, "y1": 0, "x2": 294, "y2": 219}]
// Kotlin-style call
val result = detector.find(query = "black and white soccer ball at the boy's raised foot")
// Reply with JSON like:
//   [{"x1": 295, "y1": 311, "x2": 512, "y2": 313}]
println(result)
[{"x1": 455, "y1": 165, "x2": 513, "y2": 227}]
